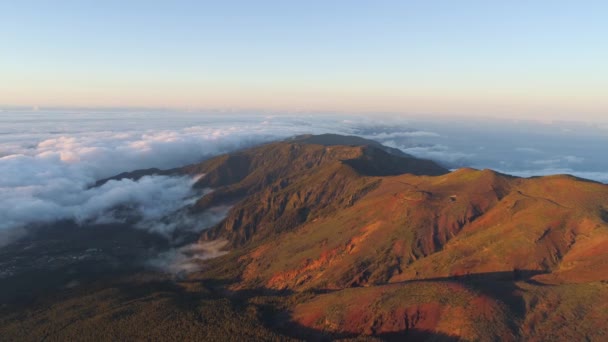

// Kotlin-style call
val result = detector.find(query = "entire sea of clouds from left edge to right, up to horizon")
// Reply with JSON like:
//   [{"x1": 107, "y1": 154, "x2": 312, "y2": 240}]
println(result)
[{"x1": 0, "y1": 110, "x2": 608, "y2": 245}]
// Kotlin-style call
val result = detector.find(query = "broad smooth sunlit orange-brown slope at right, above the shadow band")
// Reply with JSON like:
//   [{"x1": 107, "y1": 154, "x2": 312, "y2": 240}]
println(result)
[{"x1": 224, "y1": 169, "x2": 608, "y2": 288}]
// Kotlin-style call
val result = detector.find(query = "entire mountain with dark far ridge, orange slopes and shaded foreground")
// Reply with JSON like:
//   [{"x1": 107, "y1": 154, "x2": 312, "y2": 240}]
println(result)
[{"x1": 0, "y1": 135, "x2": 608, "y2": 341}]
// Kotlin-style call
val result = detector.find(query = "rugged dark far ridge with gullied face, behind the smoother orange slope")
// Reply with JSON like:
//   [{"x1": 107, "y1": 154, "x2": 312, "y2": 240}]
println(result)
[{"x1": 181, "y1": 136, "x2": 447, "y2": 246}]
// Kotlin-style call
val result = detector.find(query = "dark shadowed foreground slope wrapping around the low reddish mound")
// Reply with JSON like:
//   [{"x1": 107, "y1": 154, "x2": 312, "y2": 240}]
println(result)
[{"x1": 0, "y1": 271, "x2": 538, "y2": 341}]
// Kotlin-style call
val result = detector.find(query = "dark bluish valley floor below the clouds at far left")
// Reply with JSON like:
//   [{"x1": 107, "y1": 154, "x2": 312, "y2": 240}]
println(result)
[{"x1": 0, "y1": 221, "x2": 169, "y2": 306}]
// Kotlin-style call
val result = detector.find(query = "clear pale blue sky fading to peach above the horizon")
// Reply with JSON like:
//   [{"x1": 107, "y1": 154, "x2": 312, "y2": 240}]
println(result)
[{"x1": 0, "y1": 0, "x2": 608, "y2": 121}]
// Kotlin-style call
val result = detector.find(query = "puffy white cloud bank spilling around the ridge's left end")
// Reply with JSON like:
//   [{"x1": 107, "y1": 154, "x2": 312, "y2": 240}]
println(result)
[{"x1": 0, "y1": 117, "x2": 358, "y2": 245}]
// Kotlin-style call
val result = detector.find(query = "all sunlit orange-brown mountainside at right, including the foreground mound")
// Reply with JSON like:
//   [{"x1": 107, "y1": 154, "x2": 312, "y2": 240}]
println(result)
[{"x1": 194, "y1": 152, "x2": 608, "y2": 340}]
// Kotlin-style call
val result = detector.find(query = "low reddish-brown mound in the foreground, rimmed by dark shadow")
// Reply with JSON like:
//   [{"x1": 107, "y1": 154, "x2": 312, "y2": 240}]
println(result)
[{"x1": 275, "y1": 270, "x2": 541, "y2": 341}]
